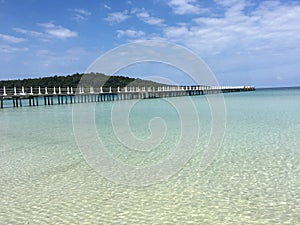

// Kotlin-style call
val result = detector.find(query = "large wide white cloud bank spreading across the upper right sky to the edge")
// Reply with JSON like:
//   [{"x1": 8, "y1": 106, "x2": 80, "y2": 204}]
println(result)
[{"x1": 164, "y1": 0, "x2": 300, "y2": 54}]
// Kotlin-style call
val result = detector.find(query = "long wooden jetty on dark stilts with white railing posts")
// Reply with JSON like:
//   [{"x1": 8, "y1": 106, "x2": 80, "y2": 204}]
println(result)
[{"x1": 0, "y1": 86, "x2": 255, "y2": 108}]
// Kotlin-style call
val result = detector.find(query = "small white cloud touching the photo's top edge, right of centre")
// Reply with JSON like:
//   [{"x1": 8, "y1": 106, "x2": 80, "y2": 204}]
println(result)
[{"x1": 168, "y1": 0, "x2": 207, "y2": 15}]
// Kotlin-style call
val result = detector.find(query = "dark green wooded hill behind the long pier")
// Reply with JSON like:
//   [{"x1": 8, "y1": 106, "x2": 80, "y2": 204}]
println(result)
[{"x1": 0, "y1": 73, "x2": 162, "y2": 88}]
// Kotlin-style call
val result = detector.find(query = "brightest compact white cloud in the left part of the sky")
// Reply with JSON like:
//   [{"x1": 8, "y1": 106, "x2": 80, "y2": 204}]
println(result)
[{"x1": 39, "y1": 23, "x2": 78, "y2": 39}]
